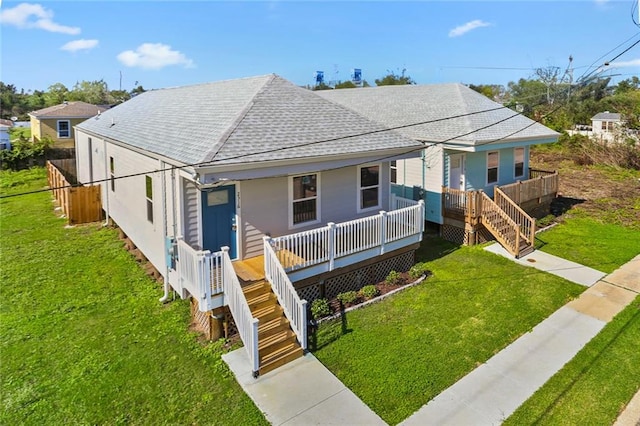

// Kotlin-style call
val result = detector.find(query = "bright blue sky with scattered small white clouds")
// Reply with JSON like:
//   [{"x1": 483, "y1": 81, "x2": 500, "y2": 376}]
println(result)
[{"x1": 0, "y1": 0, "x2": 640, "y2": 90}]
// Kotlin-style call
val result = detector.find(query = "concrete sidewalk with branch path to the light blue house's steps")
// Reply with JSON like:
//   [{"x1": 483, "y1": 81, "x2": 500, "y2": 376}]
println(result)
[{"x1": 401, "y1": 251, "x2": 640, "y2": 425}]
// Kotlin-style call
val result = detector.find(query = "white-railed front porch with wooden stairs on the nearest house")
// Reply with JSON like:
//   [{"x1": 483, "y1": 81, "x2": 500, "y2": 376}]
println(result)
[{"x1": 167, "y1": 196, "x2": 424, "y2": 376}]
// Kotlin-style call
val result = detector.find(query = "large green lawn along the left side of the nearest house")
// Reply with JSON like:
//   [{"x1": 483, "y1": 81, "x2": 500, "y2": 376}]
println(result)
[{"x1": 0, "y1": 168, "x2": 267, "y2": 425}]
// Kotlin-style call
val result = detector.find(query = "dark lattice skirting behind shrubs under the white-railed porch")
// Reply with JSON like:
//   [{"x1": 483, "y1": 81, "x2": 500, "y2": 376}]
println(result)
[{"x1": 298, "y1": 251, "x2": 415, "y2": 304}]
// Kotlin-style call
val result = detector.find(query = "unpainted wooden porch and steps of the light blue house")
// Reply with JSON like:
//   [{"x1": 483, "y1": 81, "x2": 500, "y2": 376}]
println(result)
[{"x1": 441, "y1": 168, "x2": 559, "y2": 257}]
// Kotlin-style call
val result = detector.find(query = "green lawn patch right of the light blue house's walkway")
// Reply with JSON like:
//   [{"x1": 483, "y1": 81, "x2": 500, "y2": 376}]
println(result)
[{"x1": 537, "y1": 216, "x2": 640, "y2": 272}]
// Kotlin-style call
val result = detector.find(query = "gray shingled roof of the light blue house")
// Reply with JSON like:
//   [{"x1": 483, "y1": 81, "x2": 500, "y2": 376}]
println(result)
[{"x1": 318, "y1": 83, "x2": 558, "y2": 145}]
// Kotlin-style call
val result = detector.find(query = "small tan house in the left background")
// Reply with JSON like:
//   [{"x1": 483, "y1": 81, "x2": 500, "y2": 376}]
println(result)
[{"x1": 29, "y1": 101, "x2": 108, "y2": 148}]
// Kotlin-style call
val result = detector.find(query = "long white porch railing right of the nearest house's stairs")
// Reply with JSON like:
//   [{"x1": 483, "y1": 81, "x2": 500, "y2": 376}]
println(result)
[{"x1": 270, "y1": 201, "x2": 424, "y2": 272}]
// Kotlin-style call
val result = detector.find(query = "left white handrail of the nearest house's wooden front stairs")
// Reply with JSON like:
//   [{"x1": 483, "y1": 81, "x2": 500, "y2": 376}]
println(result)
[{"x1": 221, "y1": 247, "x2": 260, "y2": 377}]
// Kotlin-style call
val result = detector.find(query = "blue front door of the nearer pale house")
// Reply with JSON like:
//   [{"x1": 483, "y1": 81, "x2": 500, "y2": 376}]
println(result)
[{"x1": 202, "y1": 185, "x2": 237, "y2": 259}]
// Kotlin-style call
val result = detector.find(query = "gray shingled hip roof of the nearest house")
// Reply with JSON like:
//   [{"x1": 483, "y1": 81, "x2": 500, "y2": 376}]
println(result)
[{"x1": 77, "y1": 75, "x2": 420, "y2": 164}]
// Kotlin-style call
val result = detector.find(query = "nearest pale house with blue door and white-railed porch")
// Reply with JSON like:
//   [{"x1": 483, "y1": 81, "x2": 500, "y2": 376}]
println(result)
[{"x1": 76, "y1": 75, "x2": 424, "y2": 375}]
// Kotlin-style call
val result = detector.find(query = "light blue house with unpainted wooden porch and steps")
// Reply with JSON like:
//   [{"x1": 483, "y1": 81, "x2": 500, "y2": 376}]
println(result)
[{"x1": 318, "y1": 84, "x2": 558, "y2": 256}]
